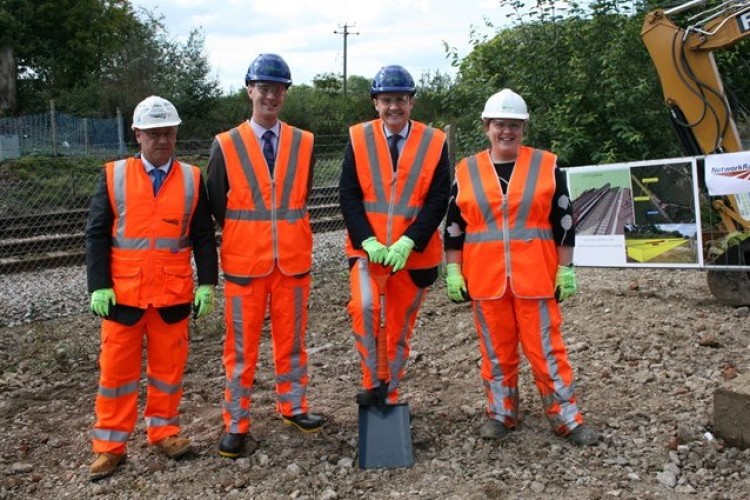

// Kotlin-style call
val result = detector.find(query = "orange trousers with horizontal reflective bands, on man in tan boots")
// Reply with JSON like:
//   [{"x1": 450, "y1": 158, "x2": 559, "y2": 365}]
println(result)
[{"x1": 93, "y1": 307, "x2": 188, "y2": 454}]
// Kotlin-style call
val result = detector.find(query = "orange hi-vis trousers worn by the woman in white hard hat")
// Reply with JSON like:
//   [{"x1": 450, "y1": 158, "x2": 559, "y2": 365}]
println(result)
[{"x1": 472, "y1": 287, "x2": 583, "y2": 435}]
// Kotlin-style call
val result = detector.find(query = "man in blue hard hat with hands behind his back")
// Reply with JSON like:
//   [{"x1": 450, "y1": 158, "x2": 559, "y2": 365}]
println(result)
[{"x1": 207, "y1": 54, "x2": 323, "y2": 458}]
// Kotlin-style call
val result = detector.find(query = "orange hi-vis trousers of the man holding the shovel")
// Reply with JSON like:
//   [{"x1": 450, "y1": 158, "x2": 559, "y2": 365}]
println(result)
[{"x1": 348, "y1": 258, "x2": 427, "y2": 404}]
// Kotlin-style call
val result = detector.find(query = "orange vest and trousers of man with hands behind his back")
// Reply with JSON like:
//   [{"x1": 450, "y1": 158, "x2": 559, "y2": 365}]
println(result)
[{"x1": 216, "y1": 122, "x2": 313, "y2": 434}]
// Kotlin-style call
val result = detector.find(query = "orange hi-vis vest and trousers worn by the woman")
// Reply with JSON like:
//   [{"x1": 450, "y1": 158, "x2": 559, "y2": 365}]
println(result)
[{"x1": 456, "y1": 146, "x2": 583, "y2": 435}]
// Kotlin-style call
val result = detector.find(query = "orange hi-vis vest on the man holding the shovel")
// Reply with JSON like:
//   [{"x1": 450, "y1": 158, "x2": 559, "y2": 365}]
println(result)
[{"x1": 346, "y1": 119, "x2": 445, "y2": 269}]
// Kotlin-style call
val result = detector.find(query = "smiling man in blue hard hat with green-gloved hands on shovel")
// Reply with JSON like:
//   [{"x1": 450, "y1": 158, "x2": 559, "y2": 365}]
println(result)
[{"x1": 339, "y1": 65, "x2": 450, "y2": 405}]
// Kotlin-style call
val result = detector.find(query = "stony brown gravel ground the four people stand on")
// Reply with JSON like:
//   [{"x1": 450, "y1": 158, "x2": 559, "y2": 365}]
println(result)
[{"x1": 0, "y1": 235, "x2": 750, "y2": 499}]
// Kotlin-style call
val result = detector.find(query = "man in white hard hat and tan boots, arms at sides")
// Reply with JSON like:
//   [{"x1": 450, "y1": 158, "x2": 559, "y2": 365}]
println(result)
[{"x1": 86, "y1": 96, "x2": 218, "y2": 480}]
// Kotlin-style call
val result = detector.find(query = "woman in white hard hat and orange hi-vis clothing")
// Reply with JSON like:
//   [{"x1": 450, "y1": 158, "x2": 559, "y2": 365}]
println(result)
[{"x1": 444, "y1": 89, "x2": 599, "y2": 445}]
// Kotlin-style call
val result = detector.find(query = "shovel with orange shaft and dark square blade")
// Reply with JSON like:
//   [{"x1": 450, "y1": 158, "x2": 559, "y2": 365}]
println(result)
[{"x1": 359, "y1": 265, "x2": 414, "y2": 469}]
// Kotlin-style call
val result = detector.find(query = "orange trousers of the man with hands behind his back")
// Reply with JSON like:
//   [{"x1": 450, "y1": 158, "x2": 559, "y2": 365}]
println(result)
[{"x1": 222, "y1": 267, "x2": 310, "y2": 434}]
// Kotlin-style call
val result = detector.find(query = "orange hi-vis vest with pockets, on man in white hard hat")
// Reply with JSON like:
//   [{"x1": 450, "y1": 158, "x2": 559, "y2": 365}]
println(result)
[{"x1": 104, "y1": 158, "x2": 200, "y2": 309}]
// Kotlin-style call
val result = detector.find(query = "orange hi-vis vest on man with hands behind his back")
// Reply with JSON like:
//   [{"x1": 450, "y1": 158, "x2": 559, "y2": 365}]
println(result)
[{"x1": 216, "y1": 121, "x2": 313, "y2": 278}]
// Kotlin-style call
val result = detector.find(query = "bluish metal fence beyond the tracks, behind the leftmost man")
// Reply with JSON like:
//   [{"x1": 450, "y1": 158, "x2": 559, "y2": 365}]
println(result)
[{"x1": 0, "y1": 103, "x2": 126, "y2": 160}]
